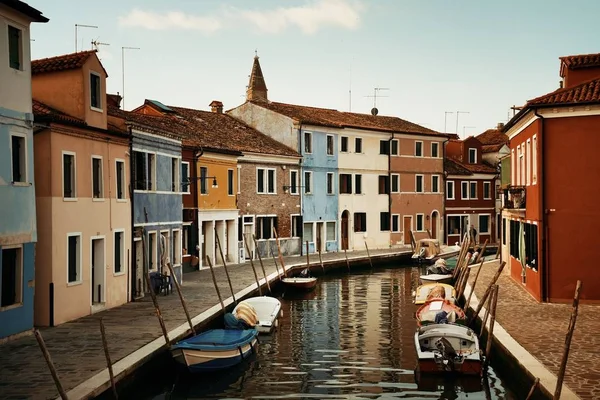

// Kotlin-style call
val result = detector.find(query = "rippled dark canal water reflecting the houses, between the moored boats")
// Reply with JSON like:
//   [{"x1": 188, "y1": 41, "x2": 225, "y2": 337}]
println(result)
[{"x1": 118, "y1": 268, "x2": 516, "y2": 399}]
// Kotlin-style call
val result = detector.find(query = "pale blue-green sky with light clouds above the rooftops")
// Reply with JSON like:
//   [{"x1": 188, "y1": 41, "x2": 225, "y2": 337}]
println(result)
[{"x1": 25, "y1": 0, "x2": 600, "y2": 137}]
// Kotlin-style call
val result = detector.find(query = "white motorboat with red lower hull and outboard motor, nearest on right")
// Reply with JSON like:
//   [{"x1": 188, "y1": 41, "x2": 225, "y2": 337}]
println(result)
[{"x1": 415, "y1": 323, "x2": 483, "y2": 376}]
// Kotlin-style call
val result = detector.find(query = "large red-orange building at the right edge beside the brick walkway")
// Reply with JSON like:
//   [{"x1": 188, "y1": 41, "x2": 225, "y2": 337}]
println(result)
[{"x1": 502, "y1": 54, "x2": 600, "y2": 302}]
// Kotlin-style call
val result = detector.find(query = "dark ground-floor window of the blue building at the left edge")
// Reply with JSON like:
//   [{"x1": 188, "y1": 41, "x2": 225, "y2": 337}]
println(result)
[{"x1": 0, "y1": 246, "x2": 23, "y2": 309}]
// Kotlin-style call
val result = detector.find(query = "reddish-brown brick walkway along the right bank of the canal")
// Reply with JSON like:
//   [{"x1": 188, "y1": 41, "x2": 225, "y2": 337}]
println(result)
[{"x1": 469, "y1": 262, "x2": 600, "y2": 400}]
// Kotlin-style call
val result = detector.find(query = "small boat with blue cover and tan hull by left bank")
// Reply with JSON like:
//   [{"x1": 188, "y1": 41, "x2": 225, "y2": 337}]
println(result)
[{"x1": 171, "y1": 329, "x2": 258, "y2": 372}]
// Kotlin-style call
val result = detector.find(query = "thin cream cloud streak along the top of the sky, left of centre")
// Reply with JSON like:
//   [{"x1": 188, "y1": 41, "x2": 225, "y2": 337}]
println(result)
[{"x1": 119, "y1": 0, "x2": 364, "y2": 35}]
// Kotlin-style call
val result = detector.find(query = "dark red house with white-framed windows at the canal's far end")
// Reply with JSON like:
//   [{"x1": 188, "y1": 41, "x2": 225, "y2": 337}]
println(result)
[{"x1": 444, "y1": 136, "x2": 496, "y2": 245}]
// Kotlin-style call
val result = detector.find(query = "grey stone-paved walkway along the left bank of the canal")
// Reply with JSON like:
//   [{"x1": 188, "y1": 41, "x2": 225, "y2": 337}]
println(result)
[{"x1": 0, "y1": 248, "x2": 406, "y2": 400}]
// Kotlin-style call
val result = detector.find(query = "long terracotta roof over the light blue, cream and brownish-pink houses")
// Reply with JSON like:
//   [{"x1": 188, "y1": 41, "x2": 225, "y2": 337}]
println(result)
[{"x1": 252, "y1": 102, "x2": 445, "y2": 136}]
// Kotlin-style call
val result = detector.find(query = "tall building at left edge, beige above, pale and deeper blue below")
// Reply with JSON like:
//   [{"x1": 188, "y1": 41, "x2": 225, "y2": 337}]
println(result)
[{"x1": 0, "y1": 0, "x2": 48, "y2": 338}]
